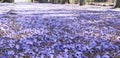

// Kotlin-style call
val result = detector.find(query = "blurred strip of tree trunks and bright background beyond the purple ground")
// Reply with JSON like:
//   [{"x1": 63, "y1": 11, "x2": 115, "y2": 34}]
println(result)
[{"x1": 0, "y1": 0, "x2": 120, "y2": 7}]
